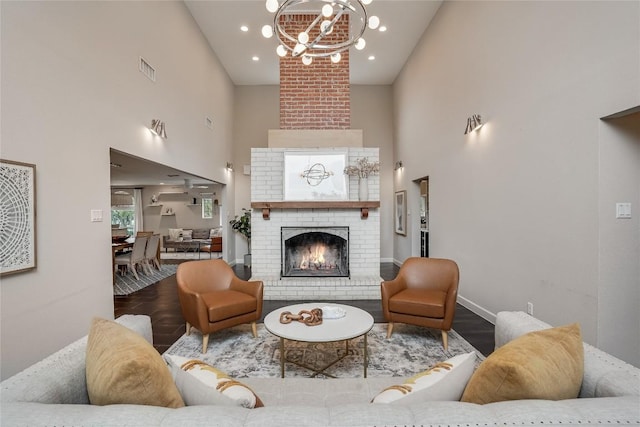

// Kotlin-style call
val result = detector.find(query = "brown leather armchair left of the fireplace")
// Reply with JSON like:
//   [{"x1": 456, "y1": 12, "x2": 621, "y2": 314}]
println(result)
[{"x1": 176, "y1": 259, "x2": 263, "y2": 353}]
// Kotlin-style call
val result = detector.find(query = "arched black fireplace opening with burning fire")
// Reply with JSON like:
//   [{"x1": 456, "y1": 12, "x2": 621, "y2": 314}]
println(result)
[{"x1": 280, "y1": 227, "x2": 349, "y2": 277}]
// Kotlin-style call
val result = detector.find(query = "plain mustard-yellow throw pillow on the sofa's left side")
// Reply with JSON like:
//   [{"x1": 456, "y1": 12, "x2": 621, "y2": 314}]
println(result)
[{"x1": 86, "y1": 318, "x2": 184, "y2": 408}]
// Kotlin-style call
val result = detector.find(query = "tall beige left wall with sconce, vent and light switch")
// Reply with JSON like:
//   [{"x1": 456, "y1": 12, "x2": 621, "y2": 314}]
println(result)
[{"x1": 0, "y1": 1, "x2": 233, "y2": 378}]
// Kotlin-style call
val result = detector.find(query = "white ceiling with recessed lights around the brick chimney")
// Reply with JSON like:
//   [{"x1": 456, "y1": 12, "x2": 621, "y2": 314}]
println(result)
[{"x1": 185, "y1": 0, "x2": 442, "y2": 85}]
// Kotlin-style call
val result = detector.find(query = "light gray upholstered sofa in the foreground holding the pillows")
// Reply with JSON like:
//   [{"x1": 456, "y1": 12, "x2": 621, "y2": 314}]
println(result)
[{"x1": 0, "y1": 312, "x2": 640, "y2": 427}]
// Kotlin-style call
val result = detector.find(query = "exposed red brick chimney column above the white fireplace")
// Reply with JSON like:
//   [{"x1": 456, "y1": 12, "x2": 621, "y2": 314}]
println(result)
[{"x1": 280, "y1": 14, "x2": 351, "y2": 129}]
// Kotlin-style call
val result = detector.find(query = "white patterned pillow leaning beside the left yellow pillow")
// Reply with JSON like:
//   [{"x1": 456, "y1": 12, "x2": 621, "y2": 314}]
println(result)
[{"x1": 164, "y1": 354, "x2": 264, "y2": 409}]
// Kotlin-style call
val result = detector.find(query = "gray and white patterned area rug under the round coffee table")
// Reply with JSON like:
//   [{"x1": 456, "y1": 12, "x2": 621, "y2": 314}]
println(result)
[{"x1": 165, "y1": 323, "x2": 484, "y2": 378}]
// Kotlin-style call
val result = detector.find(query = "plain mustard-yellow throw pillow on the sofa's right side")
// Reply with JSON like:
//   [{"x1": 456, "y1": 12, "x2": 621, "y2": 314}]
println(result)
[{"x1": 461, "y1": 323, "x2": 584, "y2": 404}]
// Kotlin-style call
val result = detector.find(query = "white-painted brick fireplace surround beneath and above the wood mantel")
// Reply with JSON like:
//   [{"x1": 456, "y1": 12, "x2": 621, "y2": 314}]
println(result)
[{"x1": 251, "y1": 147, "x2": 382, "y2": 300}]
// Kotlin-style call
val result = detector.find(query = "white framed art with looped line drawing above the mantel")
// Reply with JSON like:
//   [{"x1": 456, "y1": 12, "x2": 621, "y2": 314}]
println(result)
[{"x1": 283, "y1": 151, "x2": 349, "y2": 201}]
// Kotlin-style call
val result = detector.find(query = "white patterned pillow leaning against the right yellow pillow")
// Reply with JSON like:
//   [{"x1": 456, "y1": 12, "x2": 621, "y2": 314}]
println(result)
[{"x1": 372, "y1": 351, "x2": 477, "y2": 405}]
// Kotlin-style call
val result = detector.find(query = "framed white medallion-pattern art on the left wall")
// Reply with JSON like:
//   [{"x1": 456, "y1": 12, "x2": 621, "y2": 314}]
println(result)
[{"x1": 0, "y1": 159, "x2": 36, "y2": 276}]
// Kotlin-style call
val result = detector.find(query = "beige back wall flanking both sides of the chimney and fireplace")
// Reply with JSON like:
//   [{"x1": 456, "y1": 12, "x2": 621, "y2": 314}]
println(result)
[{"x1": 231, "y1": 85, "x2": 393, "y2": 262}]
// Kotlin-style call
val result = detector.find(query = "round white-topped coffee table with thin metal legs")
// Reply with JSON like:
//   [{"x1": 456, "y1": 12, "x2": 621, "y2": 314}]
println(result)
[{"x1": 264, "y1": 303, "x2": 373, "y2": 378}]
